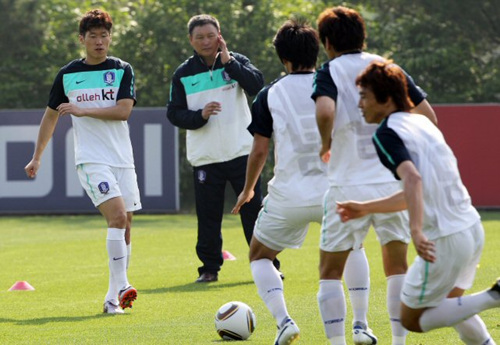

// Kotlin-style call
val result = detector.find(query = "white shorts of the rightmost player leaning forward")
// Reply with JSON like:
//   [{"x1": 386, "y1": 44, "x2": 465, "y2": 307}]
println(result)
[{"x1": 401, "y1": 222, "x2": 484, "y2": 309}]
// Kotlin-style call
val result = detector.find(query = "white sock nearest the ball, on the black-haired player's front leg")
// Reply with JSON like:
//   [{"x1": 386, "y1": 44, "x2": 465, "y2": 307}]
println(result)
[{"x1": 250, "y1": 259, "x2": 288, "y2": 325}]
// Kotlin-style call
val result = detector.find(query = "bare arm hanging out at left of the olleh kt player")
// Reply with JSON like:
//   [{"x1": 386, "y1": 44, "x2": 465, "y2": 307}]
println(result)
[{"x1": 24, "y1": 107, "x2": 59, "y2": 178}]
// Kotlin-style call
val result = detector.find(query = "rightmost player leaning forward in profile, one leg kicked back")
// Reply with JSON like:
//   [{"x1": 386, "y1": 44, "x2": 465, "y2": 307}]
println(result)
[{"x1": 337, "y1": 62, "x2": 500, "y2": 345}]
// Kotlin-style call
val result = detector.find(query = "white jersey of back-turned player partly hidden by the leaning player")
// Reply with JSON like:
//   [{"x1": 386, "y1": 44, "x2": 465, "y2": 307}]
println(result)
[{"x1": 313, "y1": 52, "x2": 424, "y2": 186}]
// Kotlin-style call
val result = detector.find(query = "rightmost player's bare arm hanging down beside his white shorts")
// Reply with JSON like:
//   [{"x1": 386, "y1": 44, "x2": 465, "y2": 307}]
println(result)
[{"x1": 396, "y1": 161, "x2": 436, "y2": 262}]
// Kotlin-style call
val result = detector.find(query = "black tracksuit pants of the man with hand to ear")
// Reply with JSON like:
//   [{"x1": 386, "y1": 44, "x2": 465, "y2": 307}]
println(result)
[{"x1": 193, "y1": 155, "x2": 279, "y2": 275}]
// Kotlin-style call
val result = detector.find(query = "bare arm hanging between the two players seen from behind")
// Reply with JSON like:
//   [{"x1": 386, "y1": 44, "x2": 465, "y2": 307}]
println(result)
[{"x1": 316, "y1": 96, "x2": 335, "y2": 163}]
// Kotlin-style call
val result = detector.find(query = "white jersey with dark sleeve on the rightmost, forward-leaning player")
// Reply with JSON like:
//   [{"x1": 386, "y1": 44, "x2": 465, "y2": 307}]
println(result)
[{"x1": 374, "y1": 112, "x2": 480, "y2": 240}]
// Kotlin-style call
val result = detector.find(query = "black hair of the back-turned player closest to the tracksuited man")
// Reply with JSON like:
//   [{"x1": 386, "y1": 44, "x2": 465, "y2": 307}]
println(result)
[{"x1": 273, "y1": 18, "x2": 319, "y2": 70}]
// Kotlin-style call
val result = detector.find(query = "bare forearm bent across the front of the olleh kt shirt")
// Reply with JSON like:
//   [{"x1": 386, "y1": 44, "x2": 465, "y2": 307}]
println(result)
[{"x1": 57, "y1": 98, "x2": 134, "y2": 121}]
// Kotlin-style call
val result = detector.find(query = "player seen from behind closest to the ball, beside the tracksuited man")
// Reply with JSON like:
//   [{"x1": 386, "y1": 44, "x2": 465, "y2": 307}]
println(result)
[{"x1": 233, "y1": 20, "x2": 369, "y2": 345}]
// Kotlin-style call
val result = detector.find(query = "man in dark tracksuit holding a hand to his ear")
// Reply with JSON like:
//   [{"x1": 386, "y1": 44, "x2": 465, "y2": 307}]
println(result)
[{"x1": 167, "y1": 14, "x2": 279, "y2": 282}]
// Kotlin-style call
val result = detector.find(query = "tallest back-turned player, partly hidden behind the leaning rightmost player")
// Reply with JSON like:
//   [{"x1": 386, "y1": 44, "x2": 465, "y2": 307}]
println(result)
[{"x1": 312, "y1": 6, "x2": 436, "y2": 345}]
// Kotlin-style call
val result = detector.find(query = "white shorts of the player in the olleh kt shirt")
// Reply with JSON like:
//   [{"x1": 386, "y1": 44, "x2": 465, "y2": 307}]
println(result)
[{"x1": 76, "y1": 164, "x2": 142, "y2": 212}]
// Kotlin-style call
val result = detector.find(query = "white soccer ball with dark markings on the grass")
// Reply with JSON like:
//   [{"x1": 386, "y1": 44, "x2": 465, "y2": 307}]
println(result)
[{"x1": 215, "y1": 301, "x2": 255, "y2": 340}]
